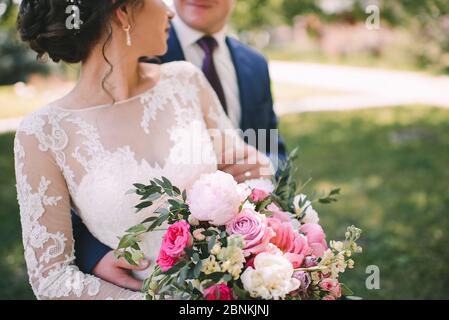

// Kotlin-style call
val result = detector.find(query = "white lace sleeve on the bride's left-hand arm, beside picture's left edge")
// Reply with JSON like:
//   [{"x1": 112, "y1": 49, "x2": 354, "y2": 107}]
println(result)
[{"x1": 14, "y1": 129, "x2": 143, "y2": 299}]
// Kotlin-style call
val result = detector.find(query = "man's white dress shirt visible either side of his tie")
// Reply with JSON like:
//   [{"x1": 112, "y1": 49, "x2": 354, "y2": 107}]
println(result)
[{"x1": 172, "y1": 15, "x2": 242, "y2": 128}]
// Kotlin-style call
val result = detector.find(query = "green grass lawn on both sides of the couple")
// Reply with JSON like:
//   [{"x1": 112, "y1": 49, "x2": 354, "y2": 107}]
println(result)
[{"x1": 0, "y1": 107, "x2": 449, "y2": 299}]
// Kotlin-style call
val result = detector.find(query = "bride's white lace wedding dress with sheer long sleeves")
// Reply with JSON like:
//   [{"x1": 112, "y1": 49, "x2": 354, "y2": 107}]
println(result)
[{"x1": 14, "y1": 62, "x2": 266, "y2": 299}]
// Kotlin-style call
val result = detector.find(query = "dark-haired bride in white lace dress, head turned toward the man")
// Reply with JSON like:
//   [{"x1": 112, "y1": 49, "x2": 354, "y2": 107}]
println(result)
[{"x1": 14, "y1": 0, "x2": 270, "y2": 299}]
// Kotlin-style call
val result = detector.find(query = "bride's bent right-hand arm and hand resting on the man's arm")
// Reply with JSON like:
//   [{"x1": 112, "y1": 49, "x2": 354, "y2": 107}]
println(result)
[{"x1": 195, "y1": 65, "x2": 274, "y2": 182}]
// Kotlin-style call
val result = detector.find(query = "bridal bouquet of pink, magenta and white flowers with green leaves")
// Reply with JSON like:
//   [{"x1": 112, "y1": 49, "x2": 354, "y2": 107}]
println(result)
[{"x1": 116, "y1": 153, "x2": 362, "y2": 300}]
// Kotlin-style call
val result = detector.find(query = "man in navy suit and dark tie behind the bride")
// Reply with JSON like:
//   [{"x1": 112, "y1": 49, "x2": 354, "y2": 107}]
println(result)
[{"x1": 72, "y1": 0, "x2": 285, "y2": 291}]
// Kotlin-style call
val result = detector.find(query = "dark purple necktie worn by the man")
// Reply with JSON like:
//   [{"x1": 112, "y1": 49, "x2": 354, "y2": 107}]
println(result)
[{"x1": 197, "y1": 36, "x2": 228, "y2": 114}]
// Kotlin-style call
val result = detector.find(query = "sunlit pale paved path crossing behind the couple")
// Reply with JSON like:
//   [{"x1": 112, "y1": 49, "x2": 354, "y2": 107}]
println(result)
[{"x1": 0, "y1": 61, "x2": 449, "y2": 133}]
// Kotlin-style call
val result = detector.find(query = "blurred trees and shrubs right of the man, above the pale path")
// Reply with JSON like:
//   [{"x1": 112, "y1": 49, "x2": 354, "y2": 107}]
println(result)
[{"x1": 233, "y1": 0, "x2": 449, "y2": 73}]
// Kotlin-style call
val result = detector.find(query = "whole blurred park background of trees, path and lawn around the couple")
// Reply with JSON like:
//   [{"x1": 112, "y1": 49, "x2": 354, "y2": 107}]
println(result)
[{"x1": 0, "y1": 0, "x2": 449, "y2": 299}]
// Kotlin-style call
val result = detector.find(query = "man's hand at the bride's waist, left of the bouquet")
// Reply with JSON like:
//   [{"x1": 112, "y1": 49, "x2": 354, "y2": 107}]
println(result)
[{"x1": 92, "y1": 251, "x2": 150, "y2": 291}]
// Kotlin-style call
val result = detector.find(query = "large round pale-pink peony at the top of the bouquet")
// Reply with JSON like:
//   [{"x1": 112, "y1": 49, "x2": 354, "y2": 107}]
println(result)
[{"x1": 187, "y1": 171, "x2": 241, "y2": 226}]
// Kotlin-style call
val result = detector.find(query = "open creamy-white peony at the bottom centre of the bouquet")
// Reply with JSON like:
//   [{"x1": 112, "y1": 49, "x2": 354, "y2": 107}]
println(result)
[{"x1": 240, "y1": 252, "x2": 301, "y2": 300}]
